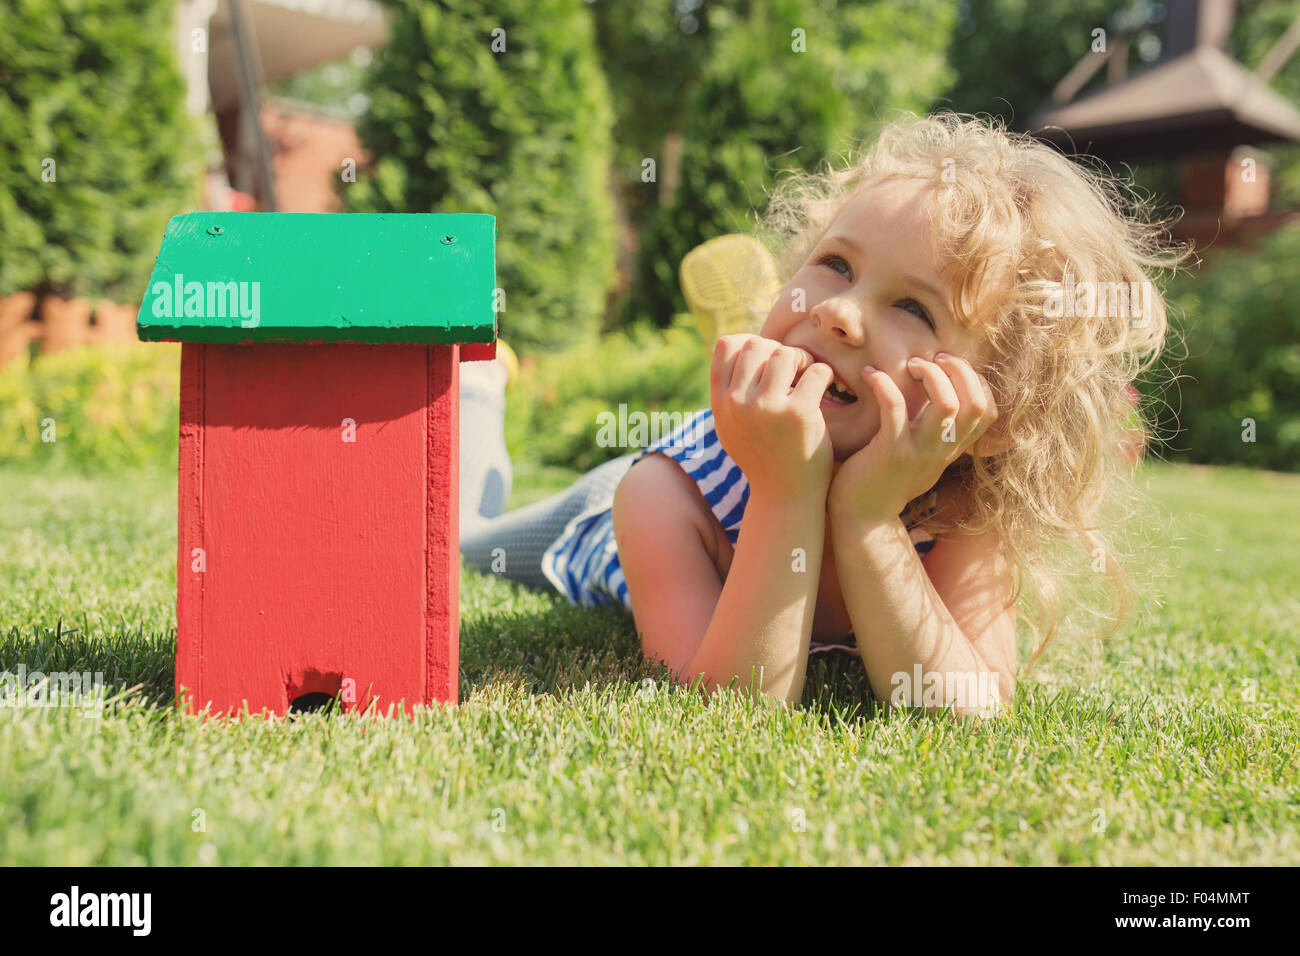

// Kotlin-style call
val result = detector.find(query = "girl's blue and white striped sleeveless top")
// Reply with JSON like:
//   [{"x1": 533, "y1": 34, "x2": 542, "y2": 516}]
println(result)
[{"x1": 542, "y1": 408, "x2": 937, "y2": 653}]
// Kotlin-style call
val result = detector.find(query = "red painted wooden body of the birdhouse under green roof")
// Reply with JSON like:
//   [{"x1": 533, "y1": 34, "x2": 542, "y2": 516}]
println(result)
[{"x1": 176, "y1": 342, "x2": 460, "y2": 714}]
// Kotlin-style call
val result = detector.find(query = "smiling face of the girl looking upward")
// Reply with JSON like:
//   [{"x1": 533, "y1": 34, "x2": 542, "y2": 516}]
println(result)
[{"x1": 759, "y1": 179, "x2": 982, "y2": 463}]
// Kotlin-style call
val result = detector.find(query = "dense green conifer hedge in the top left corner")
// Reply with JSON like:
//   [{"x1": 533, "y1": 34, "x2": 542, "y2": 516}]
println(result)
[{"x1": 0, "y1": 0, "x2": 200, "y2": 302}]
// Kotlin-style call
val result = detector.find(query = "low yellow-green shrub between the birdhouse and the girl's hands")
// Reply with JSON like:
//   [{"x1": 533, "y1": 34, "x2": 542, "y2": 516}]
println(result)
[{"x1": 506, "y1": 313, "x2": 712, "y2": 471}]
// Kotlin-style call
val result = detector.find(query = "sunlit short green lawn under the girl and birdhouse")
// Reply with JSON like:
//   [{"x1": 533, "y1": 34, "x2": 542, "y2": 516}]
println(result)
[{"x1": 0, "y1": 463, "x2": 1300, "y2": 865}]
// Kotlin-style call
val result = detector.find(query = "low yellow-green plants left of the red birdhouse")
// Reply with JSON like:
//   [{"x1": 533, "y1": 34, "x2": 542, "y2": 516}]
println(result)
[{"x1": 0, "y1": 342, "x2": 181, "y2": 473}]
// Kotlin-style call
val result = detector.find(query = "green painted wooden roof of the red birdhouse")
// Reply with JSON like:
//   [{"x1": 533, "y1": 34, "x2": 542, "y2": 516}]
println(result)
[{"x1": 137, "y1": 212, "x2": 497, "y2": 345}]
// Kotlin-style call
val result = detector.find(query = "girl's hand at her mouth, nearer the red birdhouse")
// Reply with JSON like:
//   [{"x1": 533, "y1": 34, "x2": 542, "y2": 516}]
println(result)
[{"x1": 709, "y1": 333, "x2": 835, "y2": 499}]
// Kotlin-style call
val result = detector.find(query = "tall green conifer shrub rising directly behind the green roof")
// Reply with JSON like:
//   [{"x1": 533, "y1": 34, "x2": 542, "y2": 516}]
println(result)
[{"x1": 338, "y1": 0, "x2": 615, "y2": 349}]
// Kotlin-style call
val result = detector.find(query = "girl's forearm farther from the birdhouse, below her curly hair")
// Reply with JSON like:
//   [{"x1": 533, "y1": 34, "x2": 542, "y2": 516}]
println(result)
[{"x1": 831, "y1": 518, "x2": 1001, "y2": 714}]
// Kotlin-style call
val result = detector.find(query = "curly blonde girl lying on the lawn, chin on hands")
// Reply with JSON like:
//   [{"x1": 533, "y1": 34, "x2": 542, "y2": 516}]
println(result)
[{"x1": 460, "y1": 113, "x2": 1184, "y2": 714}]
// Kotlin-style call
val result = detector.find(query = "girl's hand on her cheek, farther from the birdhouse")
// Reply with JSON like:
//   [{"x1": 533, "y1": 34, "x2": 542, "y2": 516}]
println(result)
[{"x1": 827, "y1": 352, "x2": 997, "y2": 522}]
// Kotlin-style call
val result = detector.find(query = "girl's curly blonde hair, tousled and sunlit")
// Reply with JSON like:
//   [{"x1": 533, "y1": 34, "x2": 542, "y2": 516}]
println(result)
[{"x1": 755, "y1": 112, "x2": 1191, "y2": 667}]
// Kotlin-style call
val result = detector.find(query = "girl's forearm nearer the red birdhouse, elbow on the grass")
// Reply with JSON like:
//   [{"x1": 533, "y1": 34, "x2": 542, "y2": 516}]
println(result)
[{"x1": 688, "y1": 486, "x2": 826, "y2": 704}]
